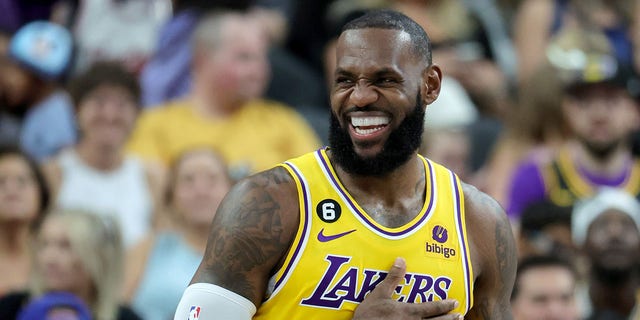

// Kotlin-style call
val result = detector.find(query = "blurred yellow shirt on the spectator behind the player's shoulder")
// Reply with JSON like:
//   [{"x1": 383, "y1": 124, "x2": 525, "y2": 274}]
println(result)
[{"x1": 127, "y1": 100, "x2": 320, "y2": 176}]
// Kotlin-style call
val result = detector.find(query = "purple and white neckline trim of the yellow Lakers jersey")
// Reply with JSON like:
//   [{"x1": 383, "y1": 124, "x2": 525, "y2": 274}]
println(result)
[{"x1": 316, "y1": 150, "x2": 435, "y2": 237}]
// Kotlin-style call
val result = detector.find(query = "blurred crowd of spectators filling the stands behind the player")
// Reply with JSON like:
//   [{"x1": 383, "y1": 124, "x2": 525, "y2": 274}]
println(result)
[{"x1": 0, "y1": 0, "x2": 640, "y2": 320}]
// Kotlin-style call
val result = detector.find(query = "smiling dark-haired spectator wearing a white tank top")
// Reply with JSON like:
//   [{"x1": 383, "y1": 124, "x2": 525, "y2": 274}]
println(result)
[{"x1": 45, "y1": 62, "x2": 161, "y2": 247}]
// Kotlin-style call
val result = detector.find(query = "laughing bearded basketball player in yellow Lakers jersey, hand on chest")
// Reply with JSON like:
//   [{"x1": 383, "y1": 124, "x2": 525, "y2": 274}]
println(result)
[{"x1": 175, "y1": 11, "x2": 516, "y2": 320}]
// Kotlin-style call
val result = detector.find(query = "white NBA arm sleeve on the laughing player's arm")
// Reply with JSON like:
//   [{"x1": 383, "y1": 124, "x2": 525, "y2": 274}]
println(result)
[{"x1": 173, "y1": 283, "x2": 256, "y2": 320}]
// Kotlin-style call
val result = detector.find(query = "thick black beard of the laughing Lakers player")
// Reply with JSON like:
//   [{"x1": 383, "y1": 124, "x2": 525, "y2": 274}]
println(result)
[{"x1": 329, "y1": 94, "x2": 425, "y2": 177}]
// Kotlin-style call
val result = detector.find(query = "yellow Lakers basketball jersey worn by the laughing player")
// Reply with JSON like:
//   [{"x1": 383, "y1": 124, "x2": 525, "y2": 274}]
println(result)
[{"x1": 254, "y1": 149, "x2": 473, "y2": 320}]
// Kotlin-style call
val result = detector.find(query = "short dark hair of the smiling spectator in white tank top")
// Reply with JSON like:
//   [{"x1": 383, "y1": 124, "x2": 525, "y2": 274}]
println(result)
[{"x1": 68, "y1": 61, "x2": 141, "y2": 111}]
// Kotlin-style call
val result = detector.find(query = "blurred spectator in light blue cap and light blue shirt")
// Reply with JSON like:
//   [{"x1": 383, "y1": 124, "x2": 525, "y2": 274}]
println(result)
[{"x1": 0, "y1": 21, "x2": 76, "y2": 162}]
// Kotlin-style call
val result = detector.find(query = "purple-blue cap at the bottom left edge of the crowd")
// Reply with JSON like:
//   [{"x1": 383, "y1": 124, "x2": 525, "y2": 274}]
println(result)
[{"x1": 16, "y1": 292, "x2": 92, "y2": 320}]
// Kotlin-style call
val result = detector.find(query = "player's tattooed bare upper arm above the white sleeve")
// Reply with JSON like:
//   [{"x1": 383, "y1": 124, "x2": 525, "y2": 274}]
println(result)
[{"x1": 191, "y1": 167, "x2": 299, "y2": 307}]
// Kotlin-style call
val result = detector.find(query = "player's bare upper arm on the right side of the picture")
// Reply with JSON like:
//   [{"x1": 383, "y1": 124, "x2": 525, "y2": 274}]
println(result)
[{"x1": 464, "y1": 185, "x2": 517, "y2": 320}]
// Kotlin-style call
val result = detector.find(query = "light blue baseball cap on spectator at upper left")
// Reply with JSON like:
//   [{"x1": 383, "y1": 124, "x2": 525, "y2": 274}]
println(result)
[{"x1": 9, "y1": 21, "x2": 73, "y2": 80}]
